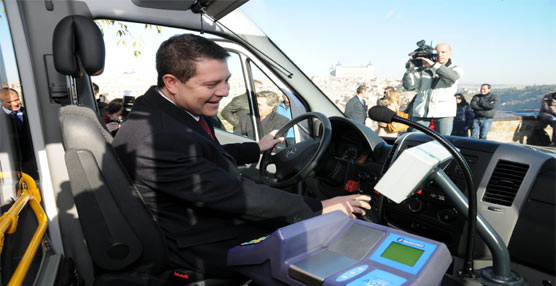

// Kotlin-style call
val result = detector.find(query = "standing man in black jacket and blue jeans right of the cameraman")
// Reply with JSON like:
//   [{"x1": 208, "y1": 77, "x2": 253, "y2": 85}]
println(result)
[{"x1": 471, "y1": 83, "x2": 498, "y2": 139}]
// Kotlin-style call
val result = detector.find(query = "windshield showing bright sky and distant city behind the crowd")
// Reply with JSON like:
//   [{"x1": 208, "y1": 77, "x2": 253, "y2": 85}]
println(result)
[{"x1": 241, "y1": 0, "x2": 556, "y2": 144}]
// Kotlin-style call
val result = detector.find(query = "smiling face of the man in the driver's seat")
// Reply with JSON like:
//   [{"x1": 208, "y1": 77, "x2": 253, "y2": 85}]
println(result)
[{"x1": 166, "y1": 59, "x2": 230, "y2": 116}]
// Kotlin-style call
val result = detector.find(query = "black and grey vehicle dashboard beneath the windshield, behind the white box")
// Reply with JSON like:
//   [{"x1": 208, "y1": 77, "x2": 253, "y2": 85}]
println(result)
[{"x1": 317, "y1": 118, "x2": 556, "y2": 275}]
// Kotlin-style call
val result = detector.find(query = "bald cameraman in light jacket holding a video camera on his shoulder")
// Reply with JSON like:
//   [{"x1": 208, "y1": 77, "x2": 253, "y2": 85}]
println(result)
[{"x1": 403, "y1": 43, "x2": 463, "y2": 135}]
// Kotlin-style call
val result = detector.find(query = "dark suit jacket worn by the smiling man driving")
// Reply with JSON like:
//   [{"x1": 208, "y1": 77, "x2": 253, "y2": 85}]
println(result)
[{"x1": 113, "y1": 87, "x2": 322, "y2": 275}]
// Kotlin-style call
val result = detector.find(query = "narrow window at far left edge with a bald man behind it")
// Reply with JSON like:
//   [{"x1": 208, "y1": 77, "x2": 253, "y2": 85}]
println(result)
[{"x1": 0, "y1": 9, "x2": 38, "y2": 202}]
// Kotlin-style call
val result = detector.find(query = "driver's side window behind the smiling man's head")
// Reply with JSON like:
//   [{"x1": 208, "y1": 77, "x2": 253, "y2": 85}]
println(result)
[{"x1": 92, "y1": 20, "x2": 304, "y2": 144}]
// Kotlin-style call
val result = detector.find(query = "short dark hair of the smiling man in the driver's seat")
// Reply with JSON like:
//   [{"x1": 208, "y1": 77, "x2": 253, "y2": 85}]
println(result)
[{"x1": 156, "y1": 34, "x2": 230, "y2": 88}]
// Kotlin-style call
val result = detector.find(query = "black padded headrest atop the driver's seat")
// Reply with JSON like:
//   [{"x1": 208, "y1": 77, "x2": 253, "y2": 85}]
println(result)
[{"x1": 52, "y1": 15, "x2": 105, "y2": 78}]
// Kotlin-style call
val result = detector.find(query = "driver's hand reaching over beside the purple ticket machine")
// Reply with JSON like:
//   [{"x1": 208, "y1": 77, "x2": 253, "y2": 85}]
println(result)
[{"x1": 321, "y1": 195, "x2": 371, "y2": 218}]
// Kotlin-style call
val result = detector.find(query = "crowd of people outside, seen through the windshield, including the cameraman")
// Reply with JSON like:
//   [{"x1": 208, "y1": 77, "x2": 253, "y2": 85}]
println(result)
[{"x1": 344, "y1": 43, "x2": 556, "y2": 145}]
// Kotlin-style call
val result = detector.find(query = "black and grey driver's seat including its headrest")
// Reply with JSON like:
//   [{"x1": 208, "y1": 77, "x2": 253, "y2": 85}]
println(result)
[{"x1": 53, "y1": 15, "x2": 230, "y2": 285}]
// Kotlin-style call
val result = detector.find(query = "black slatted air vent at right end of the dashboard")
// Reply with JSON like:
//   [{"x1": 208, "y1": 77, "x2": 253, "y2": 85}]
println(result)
[{"x1": 483, "y1": 160, "x2": 529, "y2": 206}]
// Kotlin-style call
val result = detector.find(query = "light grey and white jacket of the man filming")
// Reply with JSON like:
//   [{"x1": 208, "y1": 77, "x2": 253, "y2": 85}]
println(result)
[{"x1": 403, "y1": 59, "x2": 463, "y2": 118}]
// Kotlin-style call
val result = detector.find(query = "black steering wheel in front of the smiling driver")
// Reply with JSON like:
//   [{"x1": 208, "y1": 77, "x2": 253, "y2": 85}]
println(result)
[{"x1": 259, "y1": 112, "x2": 332, "y2": 188}]
